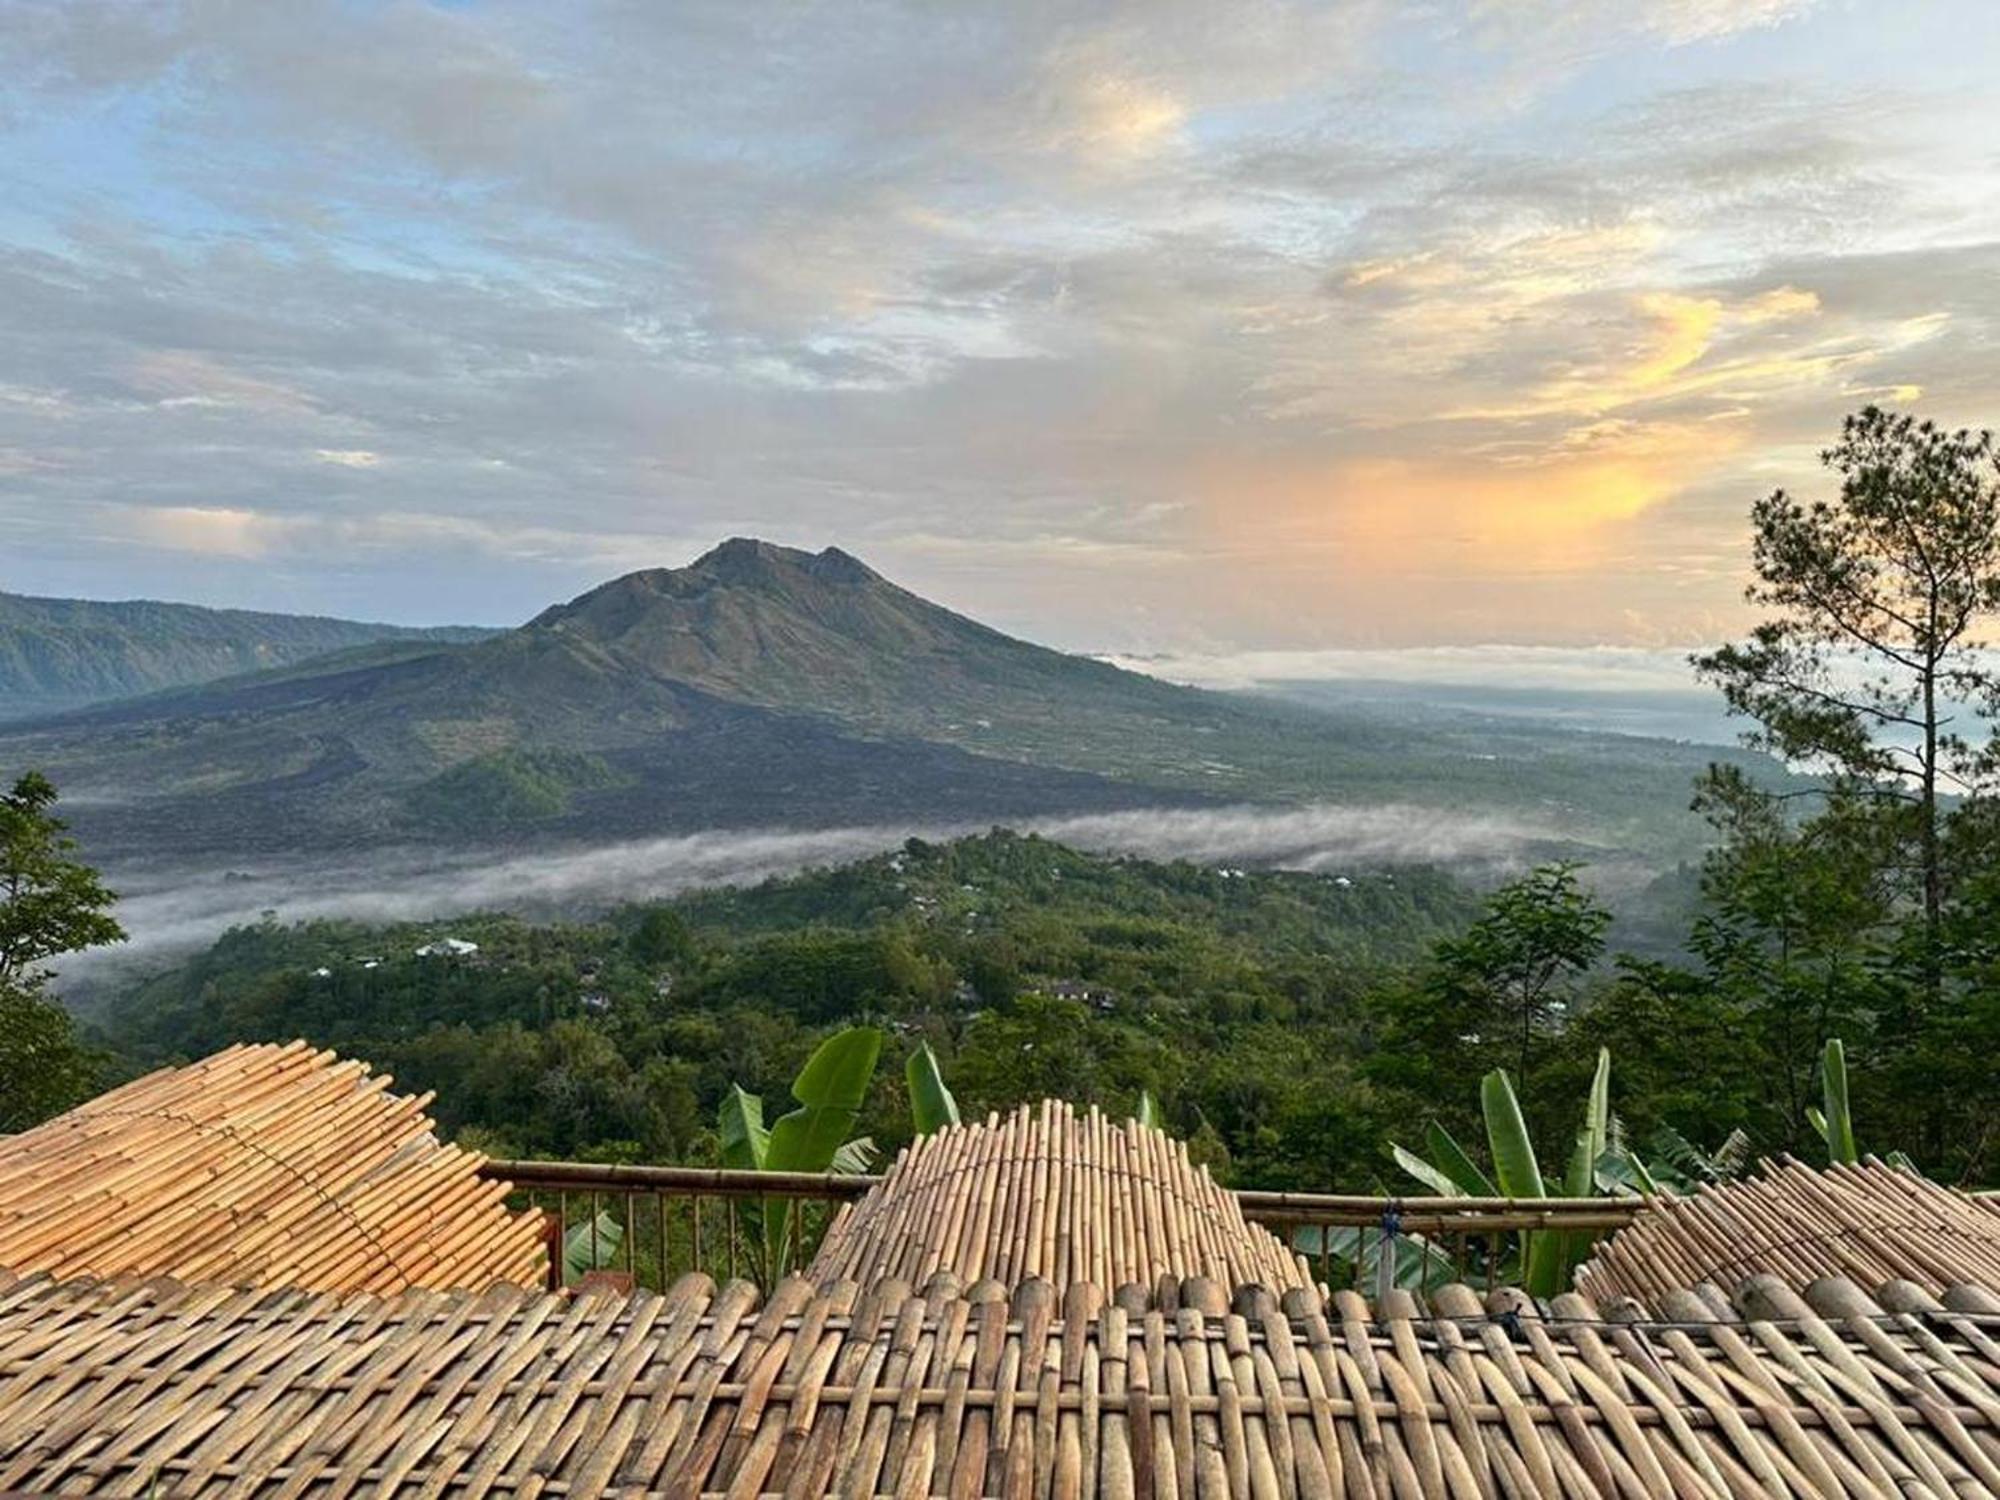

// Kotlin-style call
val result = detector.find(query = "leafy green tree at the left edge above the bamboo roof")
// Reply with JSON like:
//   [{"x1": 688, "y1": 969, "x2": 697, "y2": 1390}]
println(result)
[{"x1": 0, "y1": 772, "x2": 124, "y2": 1132}]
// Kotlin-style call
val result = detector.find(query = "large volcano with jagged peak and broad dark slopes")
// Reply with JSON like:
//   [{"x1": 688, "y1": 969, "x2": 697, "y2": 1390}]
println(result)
[{"x1": 0, "y1": 540, "x2": 1784, "y2": 864}]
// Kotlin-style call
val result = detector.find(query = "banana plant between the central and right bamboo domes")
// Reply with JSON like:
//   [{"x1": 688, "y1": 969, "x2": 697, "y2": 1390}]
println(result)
[{"x1": 1390, "y1": 1048, "x2": 1650, "y2": 1296}]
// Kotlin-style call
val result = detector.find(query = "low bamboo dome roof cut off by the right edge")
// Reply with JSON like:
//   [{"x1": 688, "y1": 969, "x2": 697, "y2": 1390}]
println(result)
[{"x1": 1576, "y1": 1158, "x2": 2000, "y2": 1302}]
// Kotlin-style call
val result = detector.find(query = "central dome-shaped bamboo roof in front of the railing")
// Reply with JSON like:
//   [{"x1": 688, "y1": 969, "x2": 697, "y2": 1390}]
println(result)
[{"x1": 808, "y1": 1100, "x2": 1310, "y2": 1290}]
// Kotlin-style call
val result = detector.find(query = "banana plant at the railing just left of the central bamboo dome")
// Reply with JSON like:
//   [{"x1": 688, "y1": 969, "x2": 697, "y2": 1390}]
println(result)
[{"x1": 716, "y1": 1026, "x2": 882, "y2": 1286}]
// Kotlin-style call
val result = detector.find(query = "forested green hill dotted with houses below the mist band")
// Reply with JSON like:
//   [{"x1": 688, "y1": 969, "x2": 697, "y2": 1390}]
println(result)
[{"x1": 102, "y1": 832, "x2": 1476, "y2": 1184}]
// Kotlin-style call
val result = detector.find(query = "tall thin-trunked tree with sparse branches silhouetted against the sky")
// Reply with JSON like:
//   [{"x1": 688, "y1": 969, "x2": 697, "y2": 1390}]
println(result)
[{"x1": 1694, "y1": 406, "x2": 2000, "y2": 1002}]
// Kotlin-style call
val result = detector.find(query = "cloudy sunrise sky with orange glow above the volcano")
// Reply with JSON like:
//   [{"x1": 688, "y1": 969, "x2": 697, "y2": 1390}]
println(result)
[{"x1": 0, "y1": 0, "x2": 2000, "y2": 662}]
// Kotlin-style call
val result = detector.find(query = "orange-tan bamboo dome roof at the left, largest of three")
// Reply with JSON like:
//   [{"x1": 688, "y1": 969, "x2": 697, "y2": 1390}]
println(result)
[{"x1": 0, "y1": 1042, "x2": 548, "y2": 1292}]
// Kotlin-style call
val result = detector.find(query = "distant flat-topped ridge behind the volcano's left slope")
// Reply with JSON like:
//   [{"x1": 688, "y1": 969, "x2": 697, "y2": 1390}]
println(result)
[{"x1": 0, "y1": 592, "x2": 488, "y2": 718}]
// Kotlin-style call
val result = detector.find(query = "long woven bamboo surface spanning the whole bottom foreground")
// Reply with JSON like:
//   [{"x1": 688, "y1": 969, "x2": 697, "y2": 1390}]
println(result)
[{"x1": 0, "y1": 1276, "x2": 2000, "y2": 1500}]
